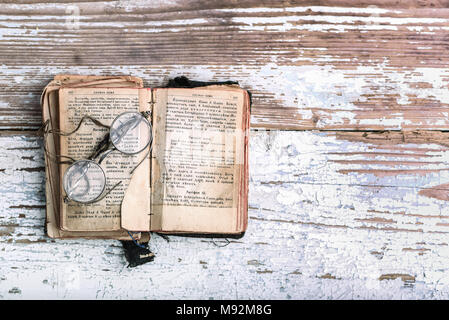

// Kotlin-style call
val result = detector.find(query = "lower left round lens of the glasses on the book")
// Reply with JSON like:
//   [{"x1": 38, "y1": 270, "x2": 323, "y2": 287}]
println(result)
[{"x1": 62, "y1": 160, "x2": 106, "y2": 203}]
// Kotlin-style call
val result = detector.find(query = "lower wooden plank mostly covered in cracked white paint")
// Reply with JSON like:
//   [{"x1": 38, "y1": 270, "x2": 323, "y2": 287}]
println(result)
[{"x1": 0, "y1": 131, "x2": 449, "y2": 299}]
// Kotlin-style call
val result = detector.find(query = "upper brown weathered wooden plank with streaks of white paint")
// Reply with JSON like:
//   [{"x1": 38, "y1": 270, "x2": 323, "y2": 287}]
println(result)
[{"x1": 0, "y1": 1, "x2": 449, "y2": 130}]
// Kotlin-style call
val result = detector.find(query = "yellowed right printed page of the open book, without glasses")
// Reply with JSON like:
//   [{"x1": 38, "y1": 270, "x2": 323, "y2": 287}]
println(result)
[{"x1": 151, "y1": 88, "x2": 244, "y2": 233}]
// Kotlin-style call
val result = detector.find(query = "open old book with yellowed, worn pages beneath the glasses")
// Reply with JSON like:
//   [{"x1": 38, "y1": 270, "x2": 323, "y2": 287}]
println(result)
[{"x1": 42, "y1": 75, "x2": 250, "y2": 239}]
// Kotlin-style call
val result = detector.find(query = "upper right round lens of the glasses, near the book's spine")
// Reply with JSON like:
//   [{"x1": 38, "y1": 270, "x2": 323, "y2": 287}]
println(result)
[{"x1": 109, "y1": 112, "x2": 152, "y2": 154}]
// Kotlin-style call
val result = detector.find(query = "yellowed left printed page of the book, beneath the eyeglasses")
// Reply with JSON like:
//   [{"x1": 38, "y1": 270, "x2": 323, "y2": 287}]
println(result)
[{"x1": 59, "y1": 88, "x2": 149, "y2": 231}]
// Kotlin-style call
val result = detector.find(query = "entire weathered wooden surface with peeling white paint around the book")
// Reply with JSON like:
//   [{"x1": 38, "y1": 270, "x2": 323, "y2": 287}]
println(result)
[{"x1": 0, "y1": 0, "x2": 449, "y2": 299}]
